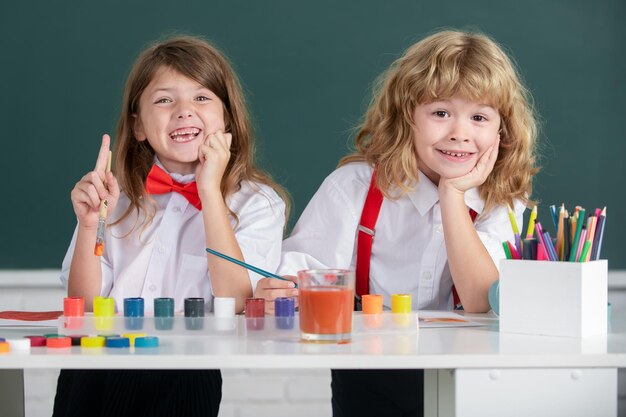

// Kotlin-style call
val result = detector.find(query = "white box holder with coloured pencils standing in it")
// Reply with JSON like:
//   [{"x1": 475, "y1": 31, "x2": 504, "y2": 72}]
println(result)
[{"x1": 500, "y1": 260, "x2": 608, "y2": 337}]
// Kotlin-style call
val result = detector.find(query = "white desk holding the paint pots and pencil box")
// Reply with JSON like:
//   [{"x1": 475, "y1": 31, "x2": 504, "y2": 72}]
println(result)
[{"x1": 0, "y1": 315, "x2": 626, "y2": 417}]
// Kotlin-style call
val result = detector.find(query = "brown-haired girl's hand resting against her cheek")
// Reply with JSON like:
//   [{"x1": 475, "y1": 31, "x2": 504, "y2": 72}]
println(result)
[{"x1": 196, "y1": 130, "x2": 233, "y2": 197}]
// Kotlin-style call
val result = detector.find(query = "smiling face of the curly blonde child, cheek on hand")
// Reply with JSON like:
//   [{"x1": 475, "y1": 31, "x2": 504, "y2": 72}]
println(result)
[{"x1": 413, "y1": 97, "x2": 500, "y2": 185}]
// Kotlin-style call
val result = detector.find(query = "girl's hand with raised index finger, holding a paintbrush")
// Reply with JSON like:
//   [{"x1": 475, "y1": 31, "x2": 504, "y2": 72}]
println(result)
[{"x1": 71, "y1": 135, "x2": 120, "y2": 229}]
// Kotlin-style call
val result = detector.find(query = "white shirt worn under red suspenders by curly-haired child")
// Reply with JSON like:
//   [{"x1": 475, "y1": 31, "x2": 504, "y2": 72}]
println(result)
[{"x1": 278, "y1": 162, "x2": 525, "y2": 310}]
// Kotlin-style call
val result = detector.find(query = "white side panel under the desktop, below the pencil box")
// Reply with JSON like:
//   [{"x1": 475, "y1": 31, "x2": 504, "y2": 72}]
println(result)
[{"x1": 450, "y1": 368, "x2": 617, "y2": 417}]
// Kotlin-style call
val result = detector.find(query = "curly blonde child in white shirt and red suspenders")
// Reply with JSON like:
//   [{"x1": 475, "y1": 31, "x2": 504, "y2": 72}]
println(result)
[{"x1": 276, "y1": 31, "x2": 537, "y2": 417}]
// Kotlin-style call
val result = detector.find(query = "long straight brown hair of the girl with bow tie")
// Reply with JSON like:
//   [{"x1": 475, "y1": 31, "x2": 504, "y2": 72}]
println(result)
[{"x1": 114, "y1": 36, "x2": 290, "y2": 226}]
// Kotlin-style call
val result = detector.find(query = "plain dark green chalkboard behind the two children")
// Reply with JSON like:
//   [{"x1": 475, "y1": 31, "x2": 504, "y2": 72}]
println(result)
[{"x1": 0, "y1": 0, "x2": 626, "y2": 269}]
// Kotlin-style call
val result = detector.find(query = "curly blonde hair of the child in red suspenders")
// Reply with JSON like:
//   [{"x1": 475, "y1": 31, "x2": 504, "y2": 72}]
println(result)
[{"x1": 339, "y1": 31, "x2": 538, "y2": 213}]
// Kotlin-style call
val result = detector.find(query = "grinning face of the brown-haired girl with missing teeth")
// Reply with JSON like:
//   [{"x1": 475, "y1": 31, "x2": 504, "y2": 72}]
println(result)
[{"x1": 134, "y1": 67, "x2": 224, "y2": 174}]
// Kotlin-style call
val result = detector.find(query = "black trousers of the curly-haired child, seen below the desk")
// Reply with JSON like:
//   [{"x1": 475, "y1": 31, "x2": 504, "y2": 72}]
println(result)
[{"x1": 331, "y1": 369, "x2": 424, "y2": 417}]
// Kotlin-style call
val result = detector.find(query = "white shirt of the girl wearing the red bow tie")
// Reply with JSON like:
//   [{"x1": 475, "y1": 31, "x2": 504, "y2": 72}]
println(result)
[{"x1": 61, "y1": 162, "x2": 285, "y2": 313}]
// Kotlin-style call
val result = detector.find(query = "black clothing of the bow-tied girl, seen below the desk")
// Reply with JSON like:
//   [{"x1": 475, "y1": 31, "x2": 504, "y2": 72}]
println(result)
[{"x1": 52, "y1": 369, "x2": 222, "y2": 417}]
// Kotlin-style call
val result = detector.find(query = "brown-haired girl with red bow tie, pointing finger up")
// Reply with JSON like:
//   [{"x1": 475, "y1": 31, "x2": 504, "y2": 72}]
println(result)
[{"x1": 54, "y1": 37, "x2": 285, "y2": 416}]
